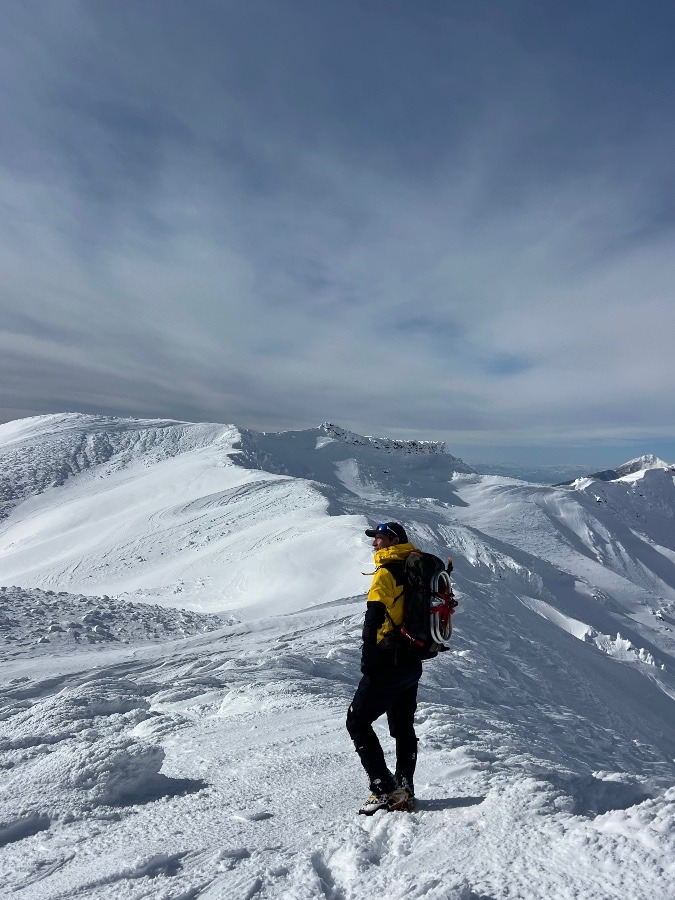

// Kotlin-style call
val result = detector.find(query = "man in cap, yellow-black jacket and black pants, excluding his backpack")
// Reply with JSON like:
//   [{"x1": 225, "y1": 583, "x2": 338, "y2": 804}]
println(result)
[{"x1": 347, "y1": 522, "x2": 422, "y2": 815}]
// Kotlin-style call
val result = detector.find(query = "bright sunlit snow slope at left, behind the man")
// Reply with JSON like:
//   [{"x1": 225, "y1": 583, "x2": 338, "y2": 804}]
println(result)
[{"x1": 0, "y1": 416, "x2": 366, "y2": 611}]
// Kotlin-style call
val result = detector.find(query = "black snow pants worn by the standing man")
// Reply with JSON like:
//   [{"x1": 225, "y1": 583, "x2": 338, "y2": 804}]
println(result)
[{"x1": 347, "y1": 660, "x2": 422, "y2": 785}]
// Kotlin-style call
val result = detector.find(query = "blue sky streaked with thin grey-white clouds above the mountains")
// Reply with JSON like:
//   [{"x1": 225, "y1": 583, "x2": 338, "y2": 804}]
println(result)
[{"x1": 0, "y1": 0, "x2": 675, "y2": 466}]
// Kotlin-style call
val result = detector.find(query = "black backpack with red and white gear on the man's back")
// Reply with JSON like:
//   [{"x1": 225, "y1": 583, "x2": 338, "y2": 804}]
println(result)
[{"x1": 385, "y1": 550, "x2": 457, "y2": 659}]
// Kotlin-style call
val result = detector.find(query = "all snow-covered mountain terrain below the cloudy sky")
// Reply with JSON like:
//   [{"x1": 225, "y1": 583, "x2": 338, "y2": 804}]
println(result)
[{"x1": 0, "y1": 416, "x2": 675, "y2": 900}]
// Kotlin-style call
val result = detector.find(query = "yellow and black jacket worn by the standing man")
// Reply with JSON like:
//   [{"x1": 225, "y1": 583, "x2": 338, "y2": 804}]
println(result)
[{"x1": 361, "y1": 543, "x2": 415, "y2": 674}]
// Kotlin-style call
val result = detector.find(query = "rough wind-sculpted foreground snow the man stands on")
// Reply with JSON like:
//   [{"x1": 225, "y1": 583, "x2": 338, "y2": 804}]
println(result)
[{"x1": 0, "y1": 590, "x2": 675, "y2": 900}]
